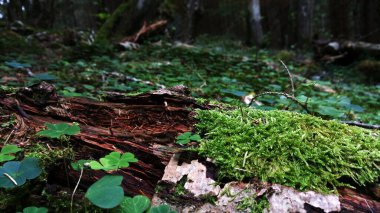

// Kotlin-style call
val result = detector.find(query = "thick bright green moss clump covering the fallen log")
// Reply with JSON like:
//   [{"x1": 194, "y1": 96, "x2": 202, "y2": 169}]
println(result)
[{"x1": 196, "y1": 109, "x2": 380, "y2": 192}]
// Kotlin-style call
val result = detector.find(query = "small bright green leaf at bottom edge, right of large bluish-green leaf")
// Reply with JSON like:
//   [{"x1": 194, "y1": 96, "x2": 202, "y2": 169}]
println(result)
[{"x1": 120, "y1": 195, "x2": 150, "y2": 213}]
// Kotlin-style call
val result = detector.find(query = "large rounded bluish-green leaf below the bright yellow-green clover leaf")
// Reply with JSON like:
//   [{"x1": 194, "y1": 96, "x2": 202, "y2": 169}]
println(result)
[{"x1": 85, "y1": 175, "x2": 124, "y2": 209}]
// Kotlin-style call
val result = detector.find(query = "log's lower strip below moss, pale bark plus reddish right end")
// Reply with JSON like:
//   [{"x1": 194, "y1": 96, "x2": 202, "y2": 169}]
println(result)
[{"x1": 153, "y1": 154, "x2": 380, "y2": 213}]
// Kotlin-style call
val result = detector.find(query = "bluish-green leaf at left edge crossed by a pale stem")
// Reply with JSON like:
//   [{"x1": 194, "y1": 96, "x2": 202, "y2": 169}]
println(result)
[{"x1": 0, "y1": 158, "x2": 41, "y2": 188}]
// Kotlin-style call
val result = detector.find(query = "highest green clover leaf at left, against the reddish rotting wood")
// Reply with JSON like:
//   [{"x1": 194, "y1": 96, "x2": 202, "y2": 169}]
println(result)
[{"x1": 37, "y1": 123, "x2": 80, "y2": 138}]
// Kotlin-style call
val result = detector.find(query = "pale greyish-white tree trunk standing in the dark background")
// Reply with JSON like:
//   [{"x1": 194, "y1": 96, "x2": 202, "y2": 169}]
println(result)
[{"x1": 249, "y1": 0, "x2": 263, "y2": 46}]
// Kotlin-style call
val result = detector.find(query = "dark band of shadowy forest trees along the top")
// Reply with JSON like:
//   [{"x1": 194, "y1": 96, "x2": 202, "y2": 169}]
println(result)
[{"x1": 0, "y1": 0, "x2": 380, "y2": 48}]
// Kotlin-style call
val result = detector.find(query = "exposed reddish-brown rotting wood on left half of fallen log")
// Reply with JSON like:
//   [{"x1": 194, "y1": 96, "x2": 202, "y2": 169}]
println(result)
[{"x1": 0, "y1": 83, "x2": 208, "y2": 197}]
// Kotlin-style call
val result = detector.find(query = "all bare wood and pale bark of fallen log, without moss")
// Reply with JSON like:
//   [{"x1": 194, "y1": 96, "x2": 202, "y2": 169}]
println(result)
[{"x1": 0, "y1": 82, "x2": 380, "y2": 212}]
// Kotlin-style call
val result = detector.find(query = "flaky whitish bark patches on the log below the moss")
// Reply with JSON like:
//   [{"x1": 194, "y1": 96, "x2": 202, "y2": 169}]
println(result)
[{"x1": 157, "y1": 154, "x2": 341, "y2": 213}]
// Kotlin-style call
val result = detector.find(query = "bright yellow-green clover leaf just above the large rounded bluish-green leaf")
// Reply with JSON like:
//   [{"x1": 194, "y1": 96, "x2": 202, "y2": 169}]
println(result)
[{"x1": 90, "y1": 152, "x2": 137, "y2": 171}]
